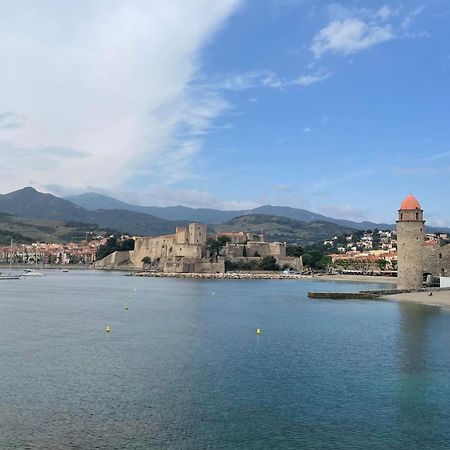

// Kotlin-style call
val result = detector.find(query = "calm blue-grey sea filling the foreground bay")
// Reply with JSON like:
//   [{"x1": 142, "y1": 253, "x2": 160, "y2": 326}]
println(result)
[{"x1": 0, "y1": 271, "x2": 450, "y2": 450}]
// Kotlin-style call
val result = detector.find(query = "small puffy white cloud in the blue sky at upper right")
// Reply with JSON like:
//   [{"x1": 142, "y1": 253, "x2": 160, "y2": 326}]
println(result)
[{"x1": 311, "y1": 18, "x2": 395, "y2": 58}]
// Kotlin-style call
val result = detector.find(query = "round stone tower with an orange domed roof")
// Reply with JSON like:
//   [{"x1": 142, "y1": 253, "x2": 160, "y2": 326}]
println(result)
[{"x1": 397, "y1": 195, "x2": 425, "y2": 289}]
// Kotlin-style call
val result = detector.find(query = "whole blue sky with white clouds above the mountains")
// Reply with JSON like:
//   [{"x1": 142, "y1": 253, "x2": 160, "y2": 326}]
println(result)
[{"x1": 0, "y1": 0, "x2": 450, "y2": 225}]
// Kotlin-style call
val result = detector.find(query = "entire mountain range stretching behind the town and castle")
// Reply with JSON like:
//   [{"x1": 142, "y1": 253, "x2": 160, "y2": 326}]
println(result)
[{"x1": 0, "y1": 187, "x2": 444, "y2": 244}]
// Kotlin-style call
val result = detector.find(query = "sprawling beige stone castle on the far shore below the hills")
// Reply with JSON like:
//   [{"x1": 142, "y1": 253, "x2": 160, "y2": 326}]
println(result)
[{"x1": 96, "y1": 223, "x2": 303, "y2": 273}]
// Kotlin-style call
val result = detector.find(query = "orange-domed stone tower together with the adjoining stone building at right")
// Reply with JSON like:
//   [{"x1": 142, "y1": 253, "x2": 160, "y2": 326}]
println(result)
[{"x1": 397, "y1": 195, "x2": 450, "y2": 289}]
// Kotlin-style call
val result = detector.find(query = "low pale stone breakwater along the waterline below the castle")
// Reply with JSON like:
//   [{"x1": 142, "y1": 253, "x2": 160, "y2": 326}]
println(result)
[{"x1": 133, "y1": 272, "x2": 312, "y2": 280}]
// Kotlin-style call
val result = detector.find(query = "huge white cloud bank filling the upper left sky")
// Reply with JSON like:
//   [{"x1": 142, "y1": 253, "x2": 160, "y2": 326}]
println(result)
[{"x1": 0, "y1": 0, "x2": 239, "y2": 191}]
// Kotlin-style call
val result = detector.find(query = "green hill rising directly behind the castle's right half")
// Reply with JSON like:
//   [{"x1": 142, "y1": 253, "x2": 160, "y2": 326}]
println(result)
[{"x1": 212, "y1": 214, "x2": 355, "y2": 246}]
